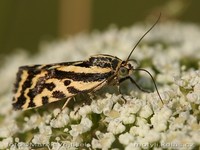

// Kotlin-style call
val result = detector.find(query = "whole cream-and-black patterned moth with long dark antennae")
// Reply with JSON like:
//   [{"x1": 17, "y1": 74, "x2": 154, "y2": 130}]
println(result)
[{"x1": 12, "y1": 17, "x2": 162, "y2": 110}]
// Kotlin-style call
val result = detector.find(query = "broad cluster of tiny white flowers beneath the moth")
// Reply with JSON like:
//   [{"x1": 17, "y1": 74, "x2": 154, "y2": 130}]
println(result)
[{"x1": 0, "y1": 23, "x2": 200, "y2": 150}]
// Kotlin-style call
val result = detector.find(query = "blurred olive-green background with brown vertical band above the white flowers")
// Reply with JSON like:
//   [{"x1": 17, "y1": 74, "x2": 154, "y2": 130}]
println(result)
[{"x1": 0, "y1": 0, "x2": 200, "y2": 60}]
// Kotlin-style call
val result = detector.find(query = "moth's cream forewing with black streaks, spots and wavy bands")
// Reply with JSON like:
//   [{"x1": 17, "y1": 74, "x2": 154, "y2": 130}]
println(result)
[{"x1": 13, "y1": 61, "x2": 113, "y2": 110}]
